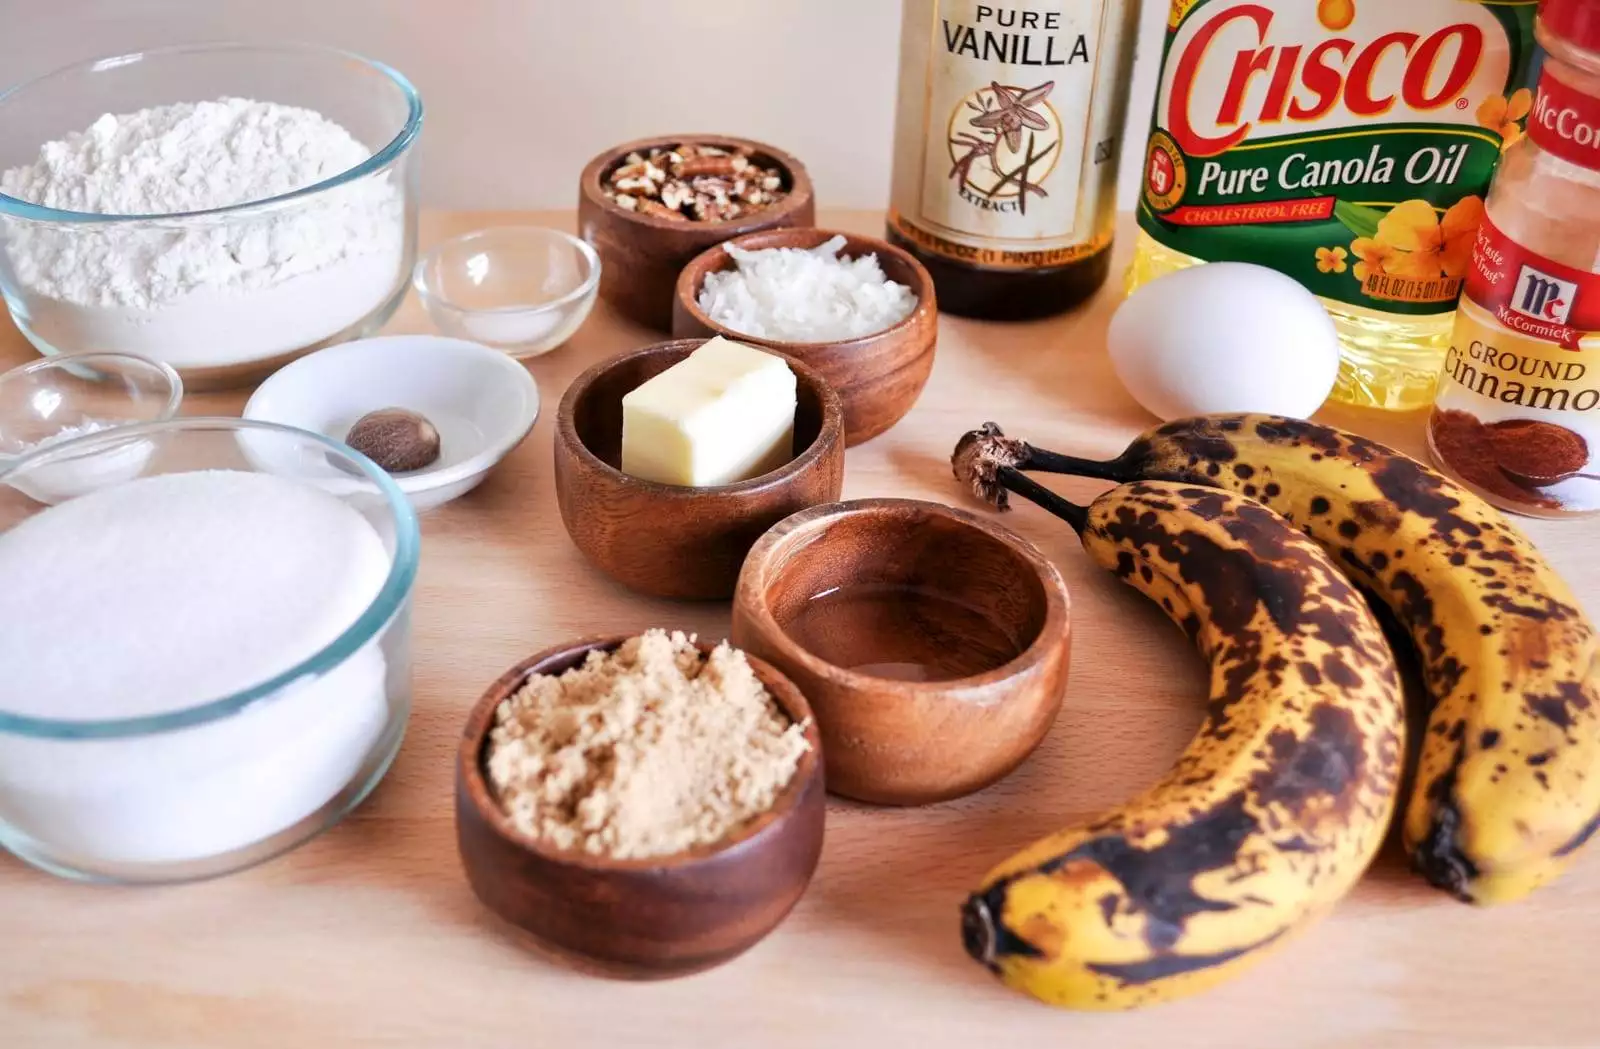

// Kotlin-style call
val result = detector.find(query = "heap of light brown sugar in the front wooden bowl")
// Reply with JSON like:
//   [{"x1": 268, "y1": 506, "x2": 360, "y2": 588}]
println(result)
[{"x1": 486, "y1": 630, "x2": 810, "y2": 859}]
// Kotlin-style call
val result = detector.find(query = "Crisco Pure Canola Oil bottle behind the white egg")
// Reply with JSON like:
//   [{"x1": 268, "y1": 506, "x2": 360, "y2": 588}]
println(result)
[{"x1": 1128, "y1": 0, "x2": 1538, "y2": 411}]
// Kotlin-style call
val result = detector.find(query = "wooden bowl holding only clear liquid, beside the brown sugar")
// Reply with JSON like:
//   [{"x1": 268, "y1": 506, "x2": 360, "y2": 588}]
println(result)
[{"x1": 733, "y1": 499, "x2": 1070, "y2": 804}]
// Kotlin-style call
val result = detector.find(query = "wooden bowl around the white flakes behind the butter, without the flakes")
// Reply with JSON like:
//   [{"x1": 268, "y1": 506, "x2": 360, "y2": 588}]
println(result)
[{"x1": 672, "y1": 229, "x2": 939, "y2": 445}]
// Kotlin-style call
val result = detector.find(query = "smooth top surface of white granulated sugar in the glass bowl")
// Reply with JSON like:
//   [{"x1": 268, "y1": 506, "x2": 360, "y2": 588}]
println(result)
[{"x1": 0, "y1": 470, "x2": 389, "y2": 718}]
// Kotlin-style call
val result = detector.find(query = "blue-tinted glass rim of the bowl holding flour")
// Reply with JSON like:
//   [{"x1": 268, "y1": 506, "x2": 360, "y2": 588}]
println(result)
[{"x1": 0, "y1": 42, "x2": 422, "y2": 225}]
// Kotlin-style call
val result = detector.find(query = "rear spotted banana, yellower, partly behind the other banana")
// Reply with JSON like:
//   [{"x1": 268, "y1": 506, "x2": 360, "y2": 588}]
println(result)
[{"x1": 960, "y1": 416, "x2": 1600, "y2": 903}]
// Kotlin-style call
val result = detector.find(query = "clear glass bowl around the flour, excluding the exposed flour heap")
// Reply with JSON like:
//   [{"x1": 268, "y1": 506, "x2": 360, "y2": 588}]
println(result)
[{"x1": 0, "y1": 45, "x2": 422, "y2": 390}]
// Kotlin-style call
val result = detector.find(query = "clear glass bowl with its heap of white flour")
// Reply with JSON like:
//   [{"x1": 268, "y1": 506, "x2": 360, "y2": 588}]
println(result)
[{"x1": 0, "y1": 45, "x2": 422, "y2": 390}]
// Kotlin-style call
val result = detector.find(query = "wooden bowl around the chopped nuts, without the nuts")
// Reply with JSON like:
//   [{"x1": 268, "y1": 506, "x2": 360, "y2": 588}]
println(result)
[{"x1": 578, "y1": 134, "x2": 816, "y2": 331}]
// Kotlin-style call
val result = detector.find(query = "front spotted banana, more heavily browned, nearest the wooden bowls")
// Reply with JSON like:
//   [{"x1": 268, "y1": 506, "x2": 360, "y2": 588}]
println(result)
[{"x1": 962, "y1": 477, "x2": 1405, "y2": 1009}]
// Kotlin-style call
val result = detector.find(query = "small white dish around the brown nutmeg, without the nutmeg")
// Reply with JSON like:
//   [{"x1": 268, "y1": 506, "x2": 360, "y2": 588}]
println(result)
[{"x1": 245, "y1": 336, "x2": 539, "y2": 512}]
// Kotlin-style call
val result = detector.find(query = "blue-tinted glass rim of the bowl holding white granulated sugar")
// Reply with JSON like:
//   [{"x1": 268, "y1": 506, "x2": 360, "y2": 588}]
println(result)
[{"x1": 0, "y1": 416, "x2": 422, "y2": 740}]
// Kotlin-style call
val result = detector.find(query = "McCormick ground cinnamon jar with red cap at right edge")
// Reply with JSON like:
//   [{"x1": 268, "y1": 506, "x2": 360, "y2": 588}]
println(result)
[{"x1": 1429, "y1": 0, "x2": 1600, "y2": 517}]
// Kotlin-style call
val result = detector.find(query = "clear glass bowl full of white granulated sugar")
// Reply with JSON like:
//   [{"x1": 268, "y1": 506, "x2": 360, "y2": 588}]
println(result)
[{"x1": 0, "y1": 419, "x2": 419, "y2": 883}]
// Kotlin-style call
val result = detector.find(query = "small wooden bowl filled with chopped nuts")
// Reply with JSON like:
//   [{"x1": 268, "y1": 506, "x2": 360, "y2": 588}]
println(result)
[{"x1": 578, "y1": 134, "x2": 816, "y2": 331}]
